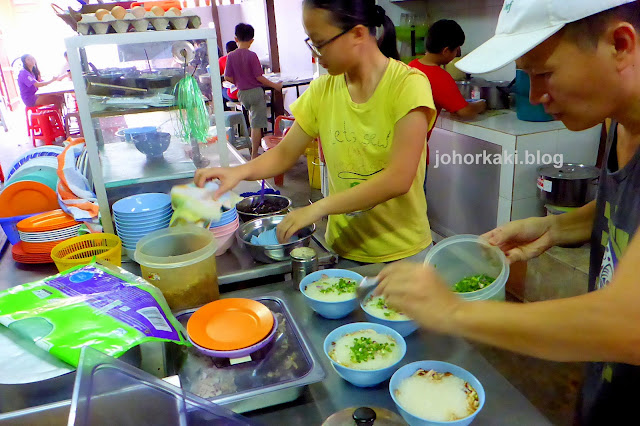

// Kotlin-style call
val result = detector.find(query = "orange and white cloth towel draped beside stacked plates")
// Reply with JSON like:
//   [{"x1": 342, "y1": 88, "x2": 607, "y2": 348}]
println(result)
[{"x1": 58, "y1": 138, "x2": 100, "y2": 231}]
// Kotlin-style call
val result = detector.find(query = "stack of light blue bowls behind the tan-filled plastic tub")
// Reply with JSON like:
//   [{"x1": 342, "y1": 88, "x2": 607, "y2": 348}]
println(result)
[{"x1": 113, "y1": 193, "x2": 173, "y2": 259}]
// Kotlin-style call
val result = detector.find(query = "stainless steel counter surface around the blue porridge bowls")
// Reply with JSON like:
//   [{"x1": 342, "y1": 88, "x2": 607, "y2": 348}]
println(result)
[{"x1": 2, "y1": 262, "x2": 551, "y2": 425}]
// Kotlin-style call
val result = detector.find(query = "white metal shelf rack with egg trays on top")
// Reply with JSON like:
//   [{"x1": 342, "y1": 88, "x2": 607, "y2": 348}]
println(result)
[{"x1": 65, "y1": 28, "x2": 229, "y2": 233}]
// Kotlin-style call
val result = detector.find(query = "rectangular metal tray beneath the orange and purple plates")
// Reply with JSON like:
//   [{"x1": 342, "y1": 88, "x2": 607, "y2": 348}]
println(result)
[{"x1": 174, "y1": 292, "x2": 326, "y2": 413}]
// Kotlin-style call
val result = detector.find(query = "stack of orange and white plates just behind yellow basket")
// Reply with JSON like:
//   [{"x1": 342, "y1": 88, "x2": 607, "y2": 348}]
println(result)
[{"x1": 16, "y1": 209, "x2": 81, "y2": 261}]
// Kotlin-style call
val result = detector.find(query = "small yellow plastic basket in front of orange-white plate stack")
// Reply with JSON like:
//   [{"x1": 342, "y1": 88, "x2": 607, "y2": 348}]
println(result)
[{"x1": 51, "y1": 233, "x2": 122, "y2": 272}]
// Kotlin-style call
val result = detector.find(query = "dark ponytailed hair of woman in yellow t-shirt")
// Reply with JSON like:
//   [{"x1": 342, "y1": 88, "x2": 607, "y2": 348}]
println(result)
[{"x1": 304, "y1": 0, "x2": 400, "y2": 60}]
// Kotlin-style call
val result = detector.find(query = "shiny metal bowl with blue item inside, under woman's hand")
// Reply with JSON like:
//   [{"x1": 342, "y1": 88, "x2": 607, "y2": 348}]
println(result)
[{"x1": 236, "y1": 215, "x2": 316, "y2": 263}]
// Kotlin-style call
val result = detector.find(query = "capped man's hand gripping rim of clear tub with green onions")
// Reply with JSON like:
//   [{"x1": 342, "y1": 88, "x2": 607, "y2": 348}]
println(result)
[{"x1": 482, "y1": 216, "x2": 555, "y2": 264}]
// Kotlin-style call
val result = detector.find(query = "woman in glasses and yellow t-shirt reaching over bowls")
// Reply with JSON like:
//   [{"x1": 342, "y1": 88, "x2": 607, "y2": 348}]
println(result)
[{"x1": 195, "y1": 0, "x2": 435, "y2": 263}]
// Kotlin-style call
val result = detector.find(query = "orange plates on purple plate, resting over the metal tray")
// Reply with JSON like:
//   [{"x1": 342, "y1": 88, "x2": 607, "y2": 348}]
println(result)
[{"x1": 187, "y1": 299, "x2": 274, "y2": 353}]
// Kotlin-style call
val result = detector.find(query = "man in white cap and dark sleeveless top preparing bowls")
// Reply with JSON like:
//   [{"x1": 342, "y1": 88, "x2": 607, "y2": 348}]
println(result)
[{"x1": 378, "y1": 0, "x2": 640, "y2": 425}]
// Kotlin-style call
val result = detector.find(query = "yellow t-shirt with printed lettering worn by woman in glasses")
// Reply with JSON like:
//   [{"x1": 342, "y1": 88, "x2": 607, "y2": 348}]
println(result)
[{"x1": 291, "y1": 59, "x2": 436, "y2": 263}]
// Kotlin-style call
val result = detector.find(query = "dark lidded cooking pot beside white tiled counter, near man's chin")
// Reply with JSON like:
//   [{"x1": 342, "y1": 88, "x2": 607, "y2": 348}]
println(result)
[{"x1": 538, "y1": 164, "x2": 600, "y2": 207}]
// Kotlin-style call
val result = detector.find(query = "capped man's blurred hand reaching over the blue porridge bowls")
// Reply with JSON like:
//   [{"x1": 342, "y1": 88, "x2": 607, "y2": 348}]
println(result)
[{"x1": 375, "y1": 262, "x2": 464, "y2": 332}]
